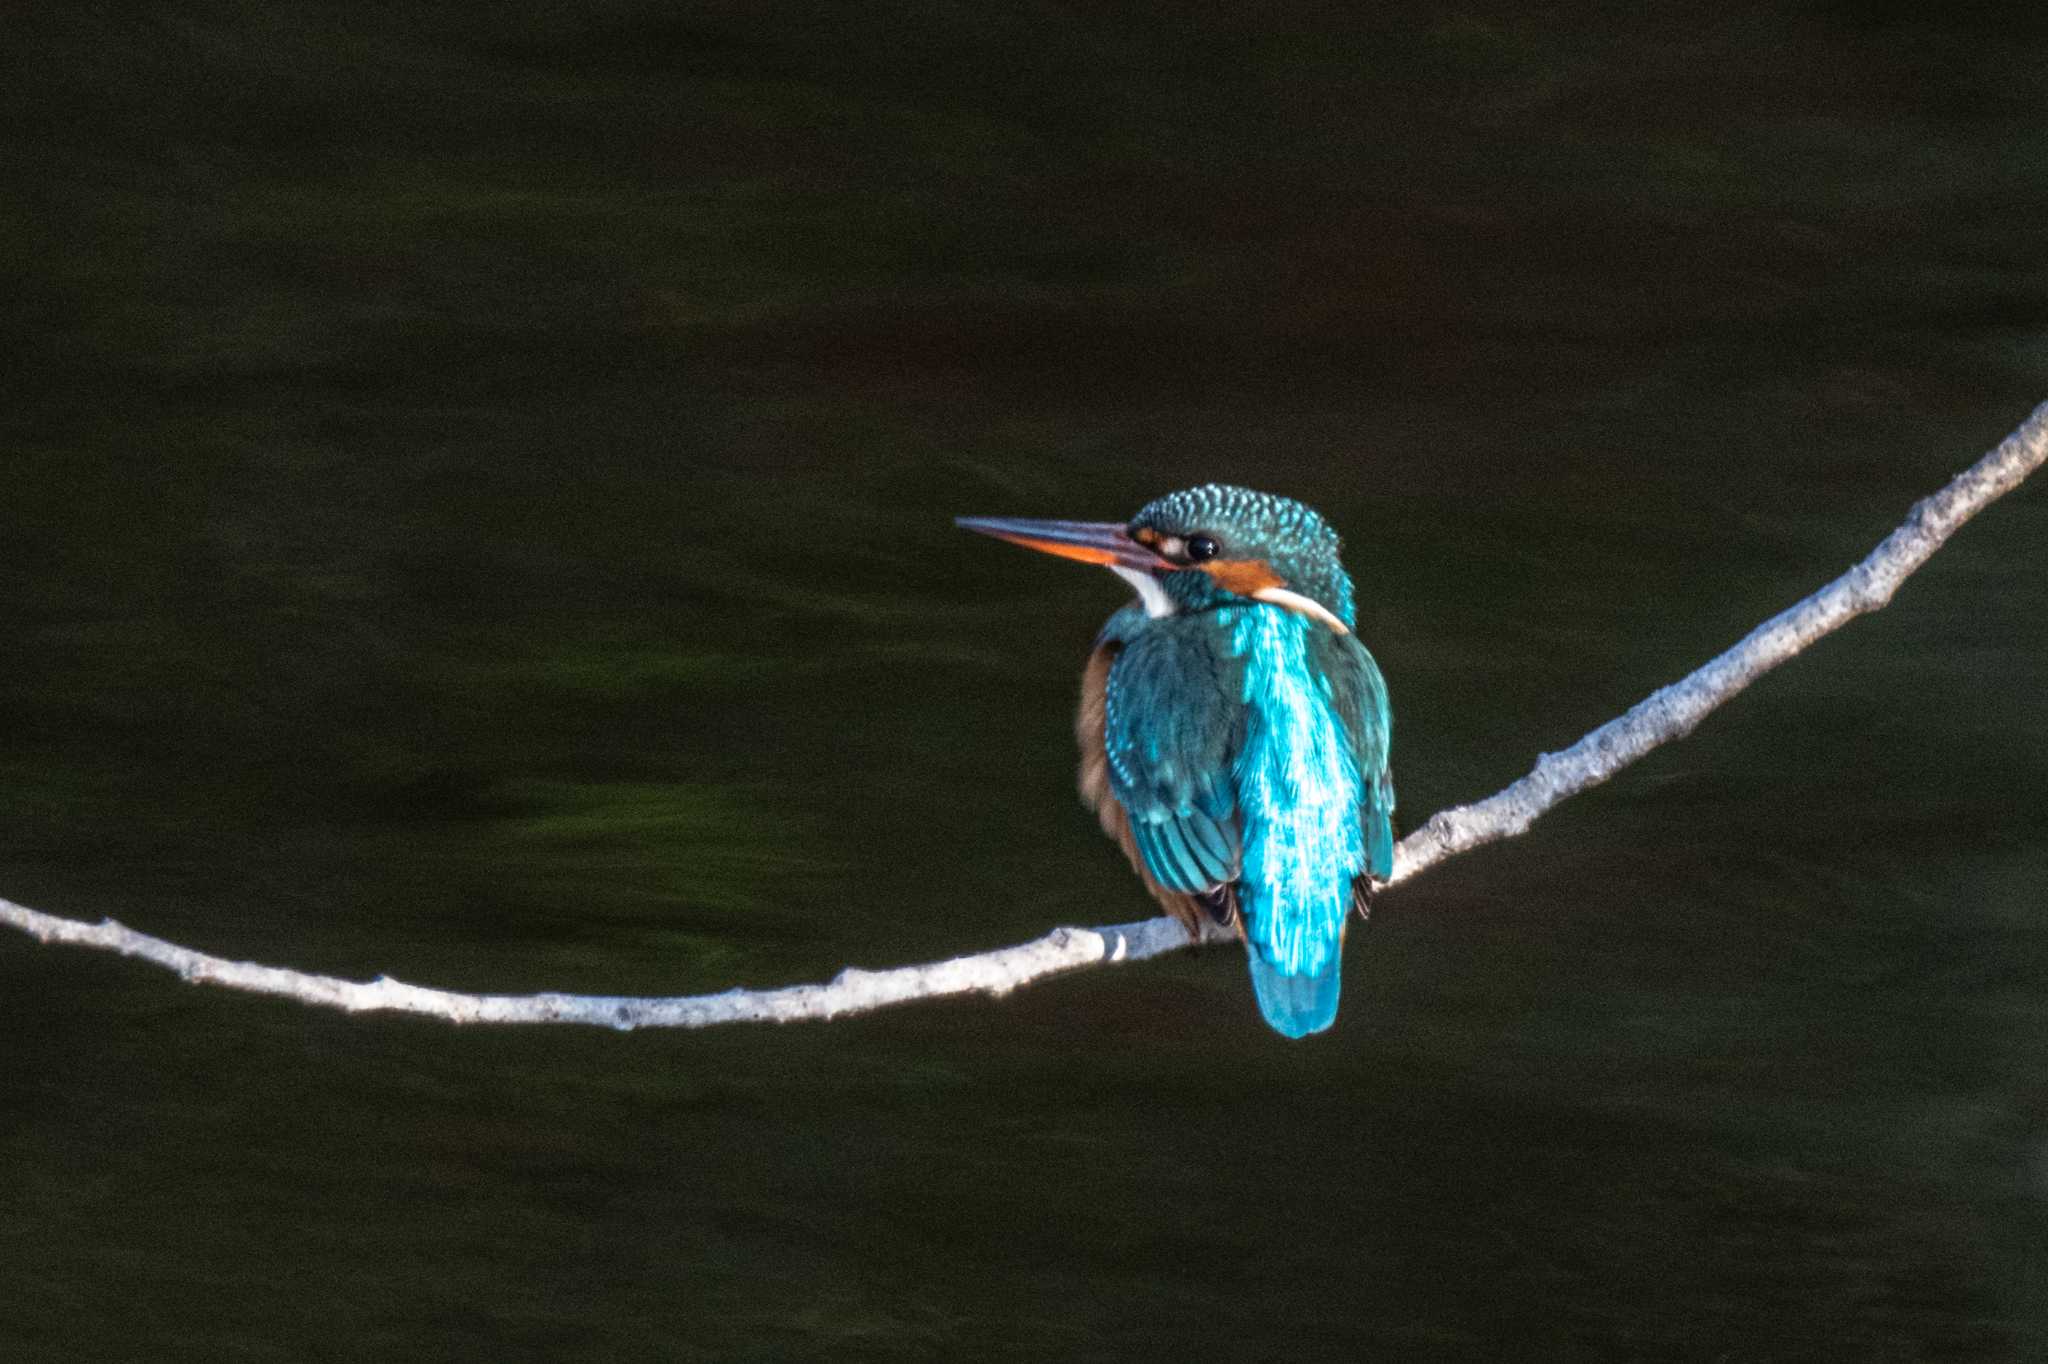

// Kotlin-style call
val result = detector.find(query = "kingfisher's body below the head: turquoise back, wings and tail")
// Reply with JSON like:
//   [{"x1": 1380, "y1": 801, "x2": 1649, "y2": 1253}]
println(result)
[{"x1": 1077, "y1": 606, "x2": 1393, "y2": 1036}]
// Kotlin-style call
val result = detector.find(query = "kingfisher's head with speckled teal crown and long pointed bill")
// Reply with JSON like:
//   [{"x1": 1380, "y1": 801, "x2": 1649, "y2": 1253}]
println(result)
[{"x1": 958, "y1": 483, "x2": 1354, "y2": 635}]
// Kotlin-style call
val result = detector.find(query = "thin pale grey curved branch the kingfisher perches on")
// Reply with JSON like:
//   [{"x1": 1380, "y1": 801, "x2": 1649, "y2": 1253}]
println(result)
[{"x1": 0, "y1": 403, "x2": 2048, "y2": 1030}]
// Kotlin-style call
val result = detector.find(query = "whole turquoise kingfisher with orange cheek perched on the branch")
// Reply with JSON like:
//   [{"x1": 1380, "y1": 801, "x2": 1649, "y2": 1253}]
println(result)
[{"x1": 956, "y1": 483, "x2": 1395, "y2": 1036}]
